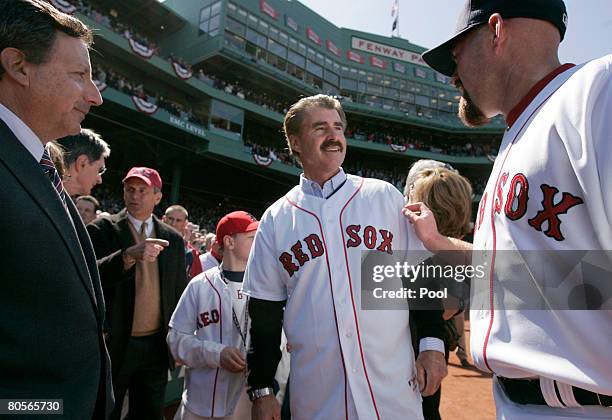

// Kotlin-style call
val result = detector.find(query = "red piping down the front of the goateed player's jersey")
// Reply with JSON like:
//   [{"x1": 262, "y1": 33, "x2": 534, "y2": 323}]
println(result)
[{"x1": 482, "y1": 74, "x2": 574, "y2": 373}]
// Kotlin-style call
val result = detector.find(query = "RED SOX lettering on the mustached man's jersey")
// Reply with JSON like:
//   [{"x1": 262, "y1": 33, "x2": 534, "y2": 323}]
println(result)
[{"x1": 278, "y1": 225, "x2": 393, "y2": 276}]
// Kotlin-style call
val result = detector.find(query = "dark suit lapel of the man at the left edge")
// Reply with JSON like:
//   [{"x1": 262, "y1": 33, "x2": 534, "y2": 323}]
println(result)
[{"x1": 0, "y1": 121, "x2": 96, "y2": 307}]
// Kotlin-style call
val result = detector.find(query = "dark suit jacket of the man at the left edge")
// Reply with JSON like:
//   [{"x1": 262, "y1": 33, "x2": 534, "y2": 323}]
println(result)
[{"x1": 0, "y1": 120, "x2": 113, "y2": 419}]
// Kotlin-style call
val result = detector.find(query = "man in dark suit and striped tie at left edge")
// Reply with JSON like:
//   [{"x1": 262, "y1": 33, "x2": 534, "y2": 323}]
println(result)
[{"x1": 0, "y1": 0, "x2": 113, "y2": 419}]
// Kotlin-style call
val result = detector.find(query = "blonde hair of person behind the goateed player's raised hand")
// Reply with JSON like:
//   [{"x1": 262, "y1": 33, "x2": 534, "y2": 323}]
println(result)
[{"x1": 410, "y1": 168, "x2": 472, "y2": 238}]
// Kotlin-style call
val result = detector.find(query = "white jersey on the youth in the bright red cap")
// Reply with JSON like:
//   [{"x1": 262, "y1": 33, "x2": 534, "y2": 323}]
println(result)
[{"x1": 167, "y1": 266, "x2": 249, "y2": 417}]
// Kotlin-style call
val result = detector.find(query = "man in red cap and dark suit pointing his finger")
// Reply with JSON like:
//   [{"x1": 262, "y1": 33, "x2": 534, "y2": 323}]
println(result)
[{"x1": 87, "y1": 167, "x2": 187, "y2": 419}]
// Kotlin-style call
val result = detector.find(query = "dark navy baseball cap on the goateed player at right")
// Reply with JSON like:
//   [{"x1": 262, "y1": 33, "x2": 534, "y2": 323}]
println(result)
[{"x1": 422, "y1": 0, "x2": 567, "y2": 76}]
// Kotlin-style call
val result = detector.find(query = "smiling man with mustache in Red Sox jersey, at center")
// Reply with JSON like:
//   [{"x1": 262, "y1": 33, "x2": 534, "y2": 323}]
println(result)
[{"x1": 243, "y1": 95, "x2": 446, "y2": 420}]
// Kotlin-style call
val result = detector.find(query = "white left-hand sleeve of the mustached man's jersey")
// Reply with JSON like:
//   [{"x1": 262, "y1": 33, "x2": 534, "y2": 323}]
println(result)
[{"x1": 242, "y1": 209, "x2": 287, "y2": 301}]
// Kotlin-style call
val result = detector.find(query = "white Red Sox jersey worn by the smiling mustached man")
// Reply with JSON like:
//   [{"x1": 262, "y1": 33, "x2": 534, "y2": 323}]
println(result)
[{"x1": 243, "y1": 175, "x2": 422, "y2": 420}]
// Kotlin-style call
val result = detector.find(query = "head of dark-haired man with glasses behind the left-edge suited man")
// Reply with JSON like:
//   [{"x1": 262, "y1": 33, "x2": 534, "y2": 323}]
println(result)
[{"x1": 58, "y1": 128, "x2": 110, "y2": 197}]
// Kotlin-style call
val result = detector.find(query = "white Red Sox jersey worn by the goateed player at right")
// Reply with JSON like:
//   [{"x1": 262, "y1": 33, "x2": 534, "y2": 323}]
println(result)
[{"x1": 470, "y1": 55, "x2": 612, "y2": 406}]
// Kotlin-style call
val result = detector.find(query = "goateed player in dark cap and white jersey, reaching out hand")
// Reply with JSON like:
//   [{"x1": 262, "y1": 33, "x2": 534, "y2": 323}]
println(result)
[{"x1": 406, "y1": 0, "x2": 612, "y2": 420}]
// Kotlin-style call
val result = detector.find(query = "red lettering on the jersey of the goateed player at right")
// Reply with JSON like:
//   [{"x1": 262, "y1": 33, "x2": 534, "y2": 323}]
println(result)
[{"x1": 476, "y1": 172, "x2": 584, "y2": 241}]
